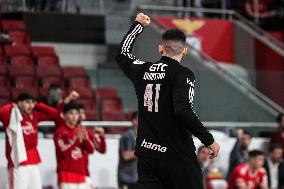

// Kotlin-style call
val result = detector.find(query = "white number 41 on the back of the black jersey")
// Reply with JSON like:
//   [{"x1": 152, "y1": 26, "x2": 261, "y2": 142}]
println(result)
[{"x1": 144, "y1": 84, "x2": 161, "y2": 112}]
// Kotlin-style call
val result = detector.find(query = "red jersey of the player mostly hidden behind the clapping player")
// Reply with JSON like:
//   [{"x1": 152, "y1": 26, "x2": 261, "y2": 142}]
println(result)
[{"x1": 84, "y1": 129, "x2": 106, "y2": 176}]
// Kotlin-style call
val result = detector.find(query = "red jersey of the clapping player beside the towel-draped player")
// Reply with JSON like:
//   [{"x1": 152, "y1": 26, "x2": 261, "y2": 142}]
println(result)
[{"x1": 54, "y1": 125, "x2": 95, "y2": 182}]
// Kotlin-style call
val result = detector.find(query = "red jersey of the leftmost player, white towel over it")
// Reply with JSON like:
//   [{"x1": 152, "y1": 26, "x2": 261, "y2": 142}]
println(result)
[{"x1": 0, "y1": 103, "x2": 58, "y2": 168}]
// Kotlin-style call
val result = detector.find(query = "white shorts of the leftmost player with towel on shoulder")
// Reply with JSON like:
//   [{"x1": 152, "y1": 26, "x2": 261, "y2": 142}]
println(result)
[{"x1": 8, "y1": 165, "x2": 42, "y2": 189}]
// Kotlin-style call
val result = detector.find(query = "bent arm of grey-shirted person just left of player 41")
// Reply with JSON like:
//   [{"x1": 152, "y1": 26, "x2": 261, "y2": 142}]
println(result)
[{"x1": 119, "y1": 136, "x2": 136, "y2": 161}]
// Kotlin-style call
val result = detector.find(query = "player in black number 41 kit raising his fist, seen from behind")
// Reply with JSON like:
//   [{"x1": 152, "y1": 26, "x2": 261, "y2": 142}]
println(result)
[{"x1": 116, "y1": 13, "x2": 220, "y2": 189}]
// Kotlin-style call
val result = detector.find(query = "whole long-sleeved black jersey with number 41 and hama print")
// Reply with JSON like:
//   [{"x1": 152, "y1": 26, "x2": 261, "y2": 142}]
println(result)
[{"x1": 116, "y1": 22, "x2": 214, "y2": 159}]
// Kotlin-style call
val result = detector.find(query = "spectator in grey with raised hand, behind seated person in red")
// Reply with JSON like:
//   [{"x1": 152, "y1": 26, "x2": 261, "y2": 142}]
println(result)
[{"x1": 228, "y1": 129, "x2": 252, "y2": 175}]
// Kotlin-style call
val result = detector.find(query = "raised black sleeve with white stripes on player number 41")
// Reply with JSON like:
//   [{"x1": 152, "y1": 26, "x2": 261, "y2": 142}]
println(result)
[{"x1": 115, "y1": 21, "x2": 145, "y2": 80}]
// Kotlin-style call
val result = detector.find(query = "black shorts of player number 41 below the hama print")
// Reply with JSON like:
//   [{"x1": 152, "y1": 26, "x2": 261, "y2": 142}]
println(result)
[{"x1": 137, "y1": 157, "x2": 204, "y2": 189}]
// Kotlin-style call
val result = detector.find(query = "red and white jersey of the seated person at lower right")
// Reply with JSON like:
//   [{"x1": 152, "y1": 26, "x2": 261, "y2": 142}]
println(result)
[{"x1": 228, "y1": 163, "x2": 268, "y2": 189}]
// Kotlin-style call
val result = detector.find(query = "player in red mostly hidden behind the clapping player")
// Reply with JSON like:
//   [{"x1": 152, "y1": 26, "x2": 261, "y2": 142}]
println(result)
[{"x1": 78, "y1": 104, "x2": 106, "y2": 189}]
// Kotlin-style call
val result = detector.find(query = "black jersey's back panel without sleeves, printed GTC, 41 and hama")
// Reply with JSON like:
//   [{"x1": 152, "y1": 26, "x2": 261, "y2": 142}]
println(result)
[{"x1": 133, "y1": 56, "x2": 195, "y2": 161}]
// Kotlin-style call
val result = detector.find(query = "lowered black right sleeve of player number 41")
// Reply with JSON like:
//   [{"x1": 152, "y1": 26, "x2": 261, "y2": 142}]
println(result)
[{"x1": 173, "y1": 70, "x2": 214, "y2": 146}]
